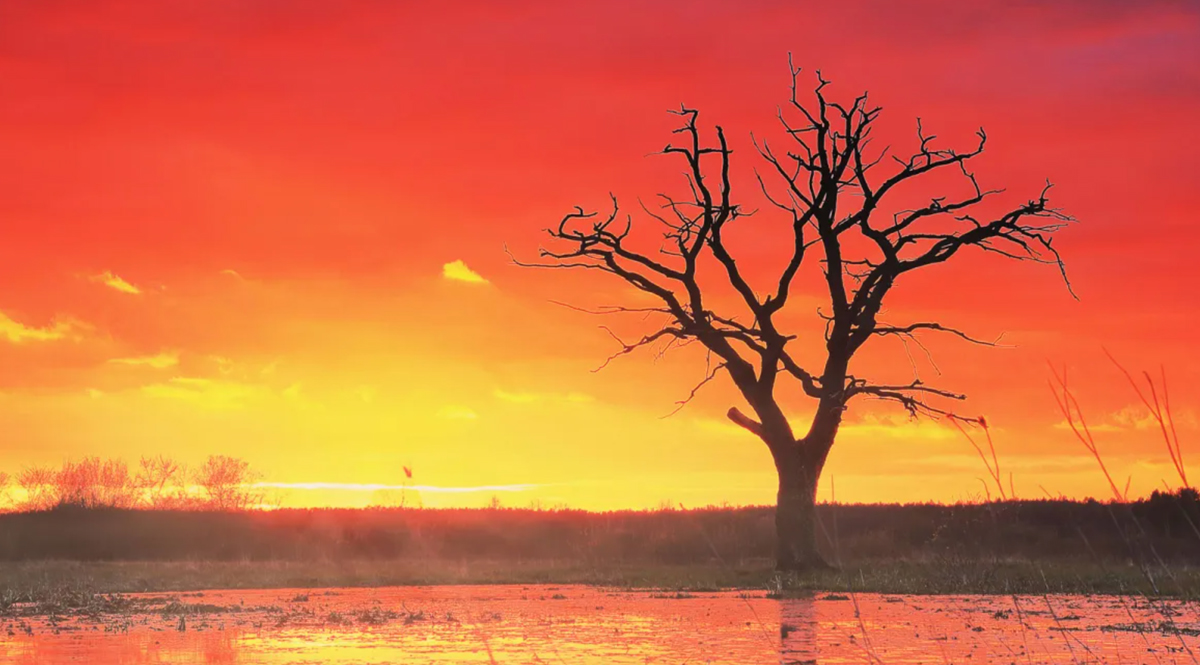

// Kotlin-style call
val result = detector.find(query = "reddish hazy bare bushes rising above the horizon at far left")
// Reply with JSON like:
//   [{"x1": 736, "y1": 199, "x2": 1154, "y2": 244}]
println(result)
[{"x1": 0, "y1": 455, "x2": 263, "y2": 511}]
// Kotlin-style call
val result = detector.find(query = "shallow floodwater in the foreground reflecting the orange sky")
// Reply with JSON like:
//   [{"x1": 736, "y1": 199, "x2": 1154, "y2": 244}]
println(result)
[{"x1": 0, "y1": 586, "x2": 1200, "y2": 665}]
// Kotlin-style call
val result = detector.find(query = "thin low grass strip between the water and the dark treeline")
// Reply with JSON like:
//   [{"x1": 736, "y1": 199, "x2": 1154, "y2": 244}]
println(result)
[{"x1": 0, "y1": 559, "x2": 1200, "y2": 599}]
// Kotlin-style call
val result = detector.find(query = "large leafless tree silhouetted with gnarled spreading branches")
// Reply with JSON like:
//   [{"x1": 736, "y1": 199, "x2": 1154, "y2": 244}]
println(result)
[{"x1": 517, "y1": 67, "x2": 1070, "y2": 570}]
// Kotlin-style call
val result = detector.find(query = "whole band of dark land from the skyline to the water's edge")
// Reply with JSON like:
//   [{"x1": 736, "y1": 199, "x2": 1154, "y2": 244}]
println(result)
[{"x1": 0, "y1": 491, "x2": 1200, "y2": 604}]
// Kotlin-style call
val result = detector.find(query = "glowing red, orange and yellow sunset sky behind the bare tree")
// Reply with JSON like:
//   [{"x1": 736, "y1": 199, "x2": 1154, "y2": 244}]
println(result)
[{"x1": 0, "y1": 0, "x2": 1200, "y2": 509}]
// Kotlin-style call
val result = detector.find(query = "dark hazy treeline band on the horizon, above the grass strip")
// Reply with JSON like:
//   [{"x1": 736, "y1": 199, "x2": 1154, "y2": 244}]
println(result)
[{"x1": 0, "y1": 489, "x2": 1200, "y2": 565}]
